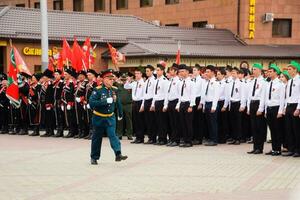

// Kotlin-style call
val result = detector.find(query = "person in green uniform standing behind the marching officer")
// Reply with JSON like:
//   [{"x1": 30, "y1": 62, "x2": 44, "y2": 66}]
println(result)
[{"x1": 115, "y1": 74, "x2": 133, "y2": 140}]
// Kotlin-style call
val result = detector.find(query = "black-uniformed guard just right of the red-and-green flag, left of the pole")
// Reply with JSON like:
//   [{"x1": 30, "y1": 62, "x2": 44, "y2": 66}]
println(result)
[{"x1": 28, "y1": 73, "x2": 42, "y2": 136}]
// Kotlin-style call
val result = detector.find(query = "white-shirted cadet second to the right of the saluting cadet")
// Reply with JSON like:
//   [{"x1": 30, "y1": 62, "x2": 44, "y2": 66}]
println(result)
[{"x1": 151, "y1": 64, "x2": 169, "y2": 145}]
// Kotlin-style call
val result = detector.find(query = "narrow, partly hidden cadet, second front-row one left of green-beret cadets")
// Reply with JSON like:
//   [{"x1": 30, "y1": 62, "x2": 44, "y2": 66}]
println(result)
[{"x1": 217, "y1": 68, "x2": 229, "y2": 144}]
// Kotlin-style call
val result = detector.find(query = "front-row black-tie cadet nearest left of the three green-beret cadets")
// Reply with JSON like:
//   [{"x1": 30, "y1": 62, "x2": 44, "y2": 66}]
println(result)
[{"x1": 224, "y1": 67, "x2": 246, "y2": 145}]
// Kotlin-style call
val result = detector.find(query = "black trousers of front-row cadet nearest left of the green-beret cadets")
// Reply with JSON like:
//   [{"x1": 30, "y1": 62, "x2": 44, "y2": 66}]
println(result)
[{"x1": 229, "y1": 101, "x2": 242, "y2": 140}]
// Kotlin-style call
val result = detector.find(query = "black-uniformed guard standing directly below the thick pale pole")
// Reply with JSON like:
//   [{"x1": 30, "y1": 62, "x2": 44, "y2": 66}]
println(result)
[{"x1": 41, "y1": 69, "x2": 55, "y2": 137}]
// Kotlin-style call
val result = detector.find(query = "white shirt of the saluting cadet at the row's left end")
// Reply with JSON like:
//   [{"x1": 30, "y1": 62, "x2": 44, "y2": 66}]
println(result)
[{"x1": 124, "y1": 78, "x2": 145, "y2": 101}]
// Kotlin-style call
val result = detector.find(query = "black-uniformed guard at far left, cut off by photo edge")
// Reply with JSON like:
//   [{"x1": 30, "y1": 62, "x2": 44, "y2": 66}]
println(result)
[{"x1": 0, "y1": 73, "x2": 9, "y2": 134}]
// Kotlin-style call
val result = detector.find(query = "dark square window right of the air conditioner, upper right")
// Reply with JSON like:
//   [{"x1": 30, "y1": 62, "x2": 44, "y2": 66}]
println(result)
[{"x1": 272, "y1": 19, "x2": 292, "y2": 37}]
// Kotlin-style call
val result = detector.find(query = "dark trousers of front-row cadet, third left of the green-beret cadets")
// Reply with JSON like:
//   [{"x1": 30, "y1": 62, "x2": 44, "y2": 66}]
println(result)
[{"x1": 204, "y1": 102, "x2": 218, "y2": 143}]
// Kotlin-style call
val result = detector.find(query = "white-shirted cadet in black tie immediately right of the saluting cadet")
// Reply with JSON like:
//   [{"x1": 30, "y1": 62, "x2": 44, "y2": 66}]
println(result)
[{"x1": 140, "y1": 65, "x2": 156, "y2": 144}]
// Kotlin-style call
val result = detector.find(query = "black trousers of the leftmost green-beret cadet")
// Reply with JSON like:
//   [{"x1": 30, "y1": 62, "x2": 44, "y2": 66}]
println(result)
[{"x1": 250, "y1": 101, "x2": 267, "y2": 151}]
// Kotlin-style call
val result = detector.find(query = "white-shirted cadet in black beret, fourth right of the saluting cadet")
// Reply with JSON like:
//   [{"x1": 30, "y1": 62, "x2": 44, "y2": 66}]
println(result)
[{"x1": 176, "y1": 64, "x2": 195, "y2": 147}]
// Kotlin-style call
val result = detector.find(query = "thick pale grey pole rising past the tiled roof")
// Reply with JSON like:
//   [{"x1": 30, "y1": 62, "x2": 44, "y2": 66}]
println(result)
[{"x1": 40, "y1": 0, "x2": 49, "y2": 71}]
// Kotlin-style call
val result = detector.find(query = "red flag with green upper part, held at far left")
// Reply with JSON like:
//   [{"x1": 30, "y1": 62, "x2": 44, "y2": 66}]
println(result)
[{"x1": 6, "y1": 47, "x2": 20, "y2": 107}]
